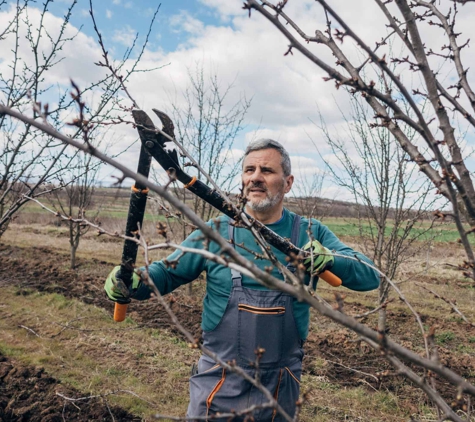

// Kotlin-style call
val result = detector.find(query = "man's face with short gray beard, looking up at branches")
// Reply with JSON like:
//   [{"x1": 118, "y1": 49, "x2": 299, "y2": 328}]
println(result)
[{"x1": 242, "y1": 148, "x2": 294, "y2": 212}]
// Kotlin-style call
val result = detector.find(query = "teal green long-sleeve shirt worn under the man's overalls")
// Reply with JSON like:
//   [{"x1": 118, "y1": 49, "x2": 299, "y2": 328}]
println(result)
[{"x1": 135, "y1": 209, "x2": 379, "y2": 340}]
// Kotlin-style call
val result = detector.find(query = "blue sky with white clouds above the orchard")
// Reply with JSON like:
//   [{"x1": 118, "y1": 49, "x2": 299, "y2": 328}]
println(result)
[{"x1": 0, "y1": 0, "x2": 475, "y2": 204}]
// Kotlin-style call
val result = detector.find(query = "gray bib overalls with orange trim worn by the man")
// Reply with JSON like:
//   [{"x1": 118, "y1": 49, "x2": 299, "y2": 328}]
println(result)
[{"x1": 187, "y1": 216, "x2": 303, "y2": 422}]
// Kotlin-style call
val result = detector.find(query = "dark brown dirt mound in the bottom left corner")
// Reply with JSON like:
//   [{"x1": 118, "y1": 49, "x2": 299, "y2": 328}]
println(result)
[{"x1": 0, "y1": 355, "x2": 140, "y2": 422}]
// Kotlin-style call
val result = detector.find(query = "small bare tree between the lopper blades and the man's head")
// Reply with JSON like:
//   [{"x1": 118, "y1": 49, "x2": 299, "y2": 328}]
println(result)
[{"x1": 172, "y1": 64, "x2": 251, "y2": 226}]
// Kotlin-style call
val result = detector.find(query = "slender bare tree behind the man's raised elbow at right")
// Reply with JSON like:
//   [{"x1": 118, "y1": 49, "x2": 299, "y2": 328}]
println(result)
[{"x1": 319, "y1": 94, "x2": 435, "y2": 330}]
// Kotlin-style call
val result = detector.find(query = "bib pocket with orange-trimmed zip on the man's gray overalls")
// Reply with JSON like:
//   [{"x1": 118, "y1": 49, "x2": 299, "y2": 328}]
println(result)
[{"x1": 238, "y1": 302, "x2": 286, "y2": 365}]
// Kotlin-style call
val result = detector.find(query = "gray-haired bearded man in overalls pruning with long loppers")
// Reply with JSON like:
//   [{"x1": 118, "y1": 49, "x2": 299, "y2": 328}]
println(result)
[{"x1": 105, "y1": 139, "x2": 379, "y2": 421}]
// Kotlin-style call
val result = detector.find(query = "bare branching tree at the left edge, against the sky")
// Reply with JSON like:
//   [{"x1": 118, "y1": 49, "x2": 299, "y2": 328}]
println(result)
[{"x1": 0, "y1": 0, "x2": 160, "y2": 241}]
